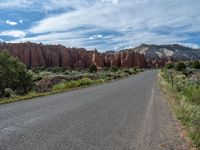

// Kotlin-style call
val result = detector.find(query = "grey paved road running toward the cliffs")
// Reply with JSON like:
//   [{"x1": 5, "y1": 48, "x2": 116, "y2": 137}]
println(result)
[{"x1": 0, "y1": 71, "x2": 187, "y2": 150}]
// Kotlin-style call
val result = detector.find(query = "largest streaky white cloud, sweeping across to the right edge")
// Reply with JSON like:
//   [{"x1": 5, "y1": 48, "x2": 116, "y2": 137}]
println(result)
[{"x1": 30, "y1": 0, "x2": 200, "y2": 33}]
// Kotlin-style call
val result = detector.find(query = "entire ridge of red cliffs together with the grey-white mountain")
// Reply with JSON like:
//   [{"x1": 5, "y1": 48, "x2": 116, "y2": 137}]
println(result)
[{"x1": 0, "y1": 42, "x2": 200, "y2": 68}]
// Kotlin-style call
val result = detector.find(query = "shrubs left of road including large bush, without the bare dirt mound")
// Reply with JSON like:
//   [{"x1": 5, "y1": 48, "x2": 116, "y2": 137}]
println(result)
[{"x1": 0, "y1": 51, "x2": 140, "y2": 97}]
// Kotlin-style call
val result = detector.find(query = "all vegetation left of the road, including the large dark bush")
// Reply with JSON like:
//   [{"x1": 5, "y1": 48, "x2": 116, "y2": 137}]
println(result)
[{"x1": 0, "y1": 51, "x2": 143, "y2": 104}]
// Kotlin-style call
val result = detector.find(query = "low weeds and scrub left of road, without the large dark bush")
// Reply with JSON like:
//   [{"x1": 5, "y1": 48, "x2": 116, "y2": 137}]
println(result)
[{"x1": 0, "y1": 68, "x2": 143, "y2": 104}]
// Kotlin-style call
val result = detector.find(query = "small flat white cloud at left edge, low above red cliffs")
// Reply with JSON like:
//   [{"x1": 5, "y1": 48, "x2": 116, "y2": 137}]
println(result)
[{"x1": 0, "y1": 30, "x2": 26, "y2": 38}]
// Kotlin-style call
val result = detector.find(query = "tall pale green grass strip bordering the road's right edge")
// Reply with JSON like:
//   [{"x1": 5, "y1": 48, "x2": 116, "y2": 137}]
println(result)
[{"x1": 158, "y1": 71, "x2": 200, "y2": 149}]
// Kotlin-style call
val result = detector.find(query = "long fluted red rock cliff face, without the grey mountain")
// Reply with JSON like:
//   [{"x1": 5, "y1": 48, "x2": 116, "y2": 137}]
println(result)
[{"x1": 0, "y1": 42, "x2": 147, "y2": 69}]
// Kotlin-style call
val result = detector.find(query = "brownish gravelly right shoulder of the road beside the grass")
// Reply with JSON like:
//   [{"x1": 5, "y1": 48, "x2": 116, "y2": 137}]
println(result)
[{"x1": 136, "y1": 81, "x2": 191, "y2": 150}]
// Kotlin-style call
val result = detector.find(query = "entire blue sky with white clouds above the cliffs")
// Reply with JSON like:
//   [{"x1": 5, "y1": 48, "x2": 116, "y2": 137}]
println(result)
[{"x1": 0, "y1": 0, "x2": 200, "y2": 51}]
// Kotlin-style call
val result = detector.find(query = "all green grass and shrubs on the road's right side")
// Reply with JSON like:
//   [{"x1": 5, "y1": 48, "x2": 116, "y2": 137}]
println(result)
[{"x1": 159, "y1": 61, "x2": 200, "y2": 148}]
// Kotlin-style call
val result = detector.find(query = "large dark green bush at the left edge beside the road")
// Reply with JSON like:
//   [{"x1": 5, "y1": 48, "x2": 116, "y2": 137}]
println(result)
[{"x1": 0, "y1": 50, "x2": 33, "y2": 97}]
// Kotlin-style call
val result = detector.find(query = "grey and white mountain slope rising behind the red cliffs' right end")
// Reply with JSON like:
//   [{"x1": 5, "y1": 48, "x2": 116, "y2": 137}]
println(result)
[{"x1": 125, "y1": 44, "x2": 200, "y2": 67}]
